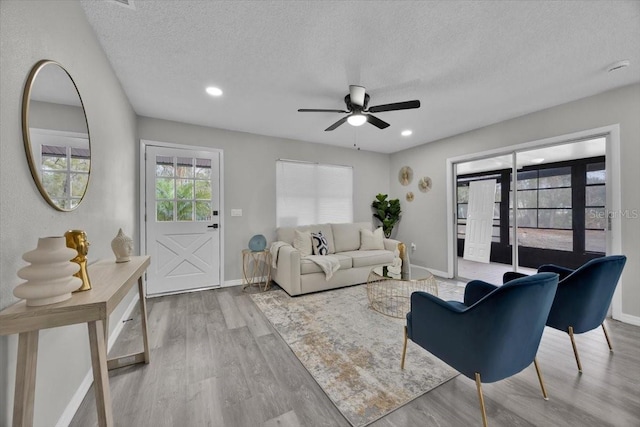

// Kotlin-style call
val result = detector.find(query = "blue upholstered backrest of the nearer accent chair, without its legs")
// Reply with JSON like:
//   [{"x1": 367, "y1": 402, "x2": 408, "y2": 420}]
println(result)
[{"x1": 411, "y1": 273, "x2": 558, "y2": 383}]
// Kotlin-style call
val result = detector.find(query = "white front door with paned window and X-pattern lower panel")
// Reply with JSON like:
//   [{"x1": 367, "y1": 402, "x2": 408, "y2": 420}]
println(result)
[{"x1": 145, "y1": 145, "x2": 221, "y2": 295}]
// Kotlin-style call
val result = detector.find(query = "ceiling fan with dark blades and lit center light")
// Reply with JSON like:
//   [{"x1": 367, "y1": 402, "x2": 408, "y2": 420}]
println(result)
[{"x1": 298, "y1": 85, "x2": 420, "y2": 131}]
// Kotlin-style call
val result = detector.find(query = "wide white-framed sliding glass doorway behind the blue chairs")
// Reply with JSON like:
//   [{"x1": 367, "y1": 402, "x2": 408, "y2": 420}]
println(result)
[{"x1": 447, "y1": 125, "x2": 620, "y2": 298}]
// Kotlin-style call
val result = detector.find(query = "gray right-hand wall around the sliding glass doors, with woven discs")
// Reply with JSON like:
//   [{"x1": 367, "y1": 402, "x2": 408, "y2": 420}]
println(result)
[{"x1": 391, "y1": 84, "x2": 640, "y2": 317}]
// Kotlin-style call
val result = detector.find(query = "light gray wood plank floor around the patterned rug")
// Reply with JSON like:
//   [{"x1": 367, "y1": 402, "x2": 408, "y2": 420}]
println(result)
[{"x1": 71, "y1": 287, "x2": 640, "y2": 427}]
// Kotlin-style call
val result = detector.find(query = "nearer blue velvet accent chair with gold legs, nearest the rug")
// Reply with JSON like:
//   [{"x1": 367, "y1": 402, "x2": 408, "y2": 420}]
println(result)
[{"x1": 401, "y1": 273, "x2": 558, "y2": 426}]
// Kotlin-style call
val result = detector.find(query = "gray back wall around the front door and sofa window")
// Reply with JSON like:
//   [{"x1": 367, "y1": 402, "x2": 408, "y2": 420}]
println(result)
[{"x1": 138, "y1": 117, "x2": 389, "y2": 281}]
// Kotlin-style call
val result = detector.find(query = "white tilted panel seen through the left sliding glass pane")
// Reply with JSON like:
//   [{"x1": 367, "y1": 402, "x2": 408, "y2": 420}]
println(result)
[{"x1": 464, "y1": 179, "x2": 496, "y2": 263}]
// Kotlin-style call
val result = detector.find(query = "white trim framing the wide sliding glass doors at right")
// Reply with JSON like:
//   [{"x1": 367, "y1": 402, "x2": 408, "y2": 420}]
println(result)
[{"x1": 446, "y1": 123, "x2": 628, "y2": 322}]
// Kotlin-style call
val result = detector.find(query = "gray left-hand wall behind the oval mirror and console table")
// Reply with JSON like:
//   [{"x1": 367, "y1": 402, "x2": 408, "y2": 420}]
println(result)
[{"x1": 0, "y1": 0, "x2": 138, "y2": 426}]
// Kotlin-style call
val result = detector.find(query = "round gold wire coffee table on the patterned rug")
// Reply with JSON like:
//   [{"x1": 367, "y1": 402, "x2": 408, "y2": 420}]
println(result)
[{"x1": 367, "y1": 266, "x2": 438, "y2": 319}]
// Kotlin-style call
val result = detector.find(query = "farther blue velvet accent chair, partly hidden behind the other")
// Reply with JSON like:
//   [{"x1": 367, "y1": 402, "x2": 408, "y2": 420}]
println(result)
[{"x1": 503, "y1": 255, "x2": 627, "y2": 372}]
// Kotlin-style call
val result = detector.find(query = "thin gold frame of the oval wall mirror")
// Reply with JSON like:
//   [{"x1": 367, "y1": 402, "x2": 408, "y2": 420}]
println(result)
[{"x1": 22, "y1": 59, "x2": 91, "y2": 212}]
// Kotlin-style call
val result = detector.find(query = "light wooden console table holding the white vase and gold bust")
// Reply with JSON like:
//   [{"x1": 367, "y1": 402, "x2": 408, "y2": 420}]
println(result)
[{"x1": 0, "y1": 256, "x2": 150, "y2": 427}]
